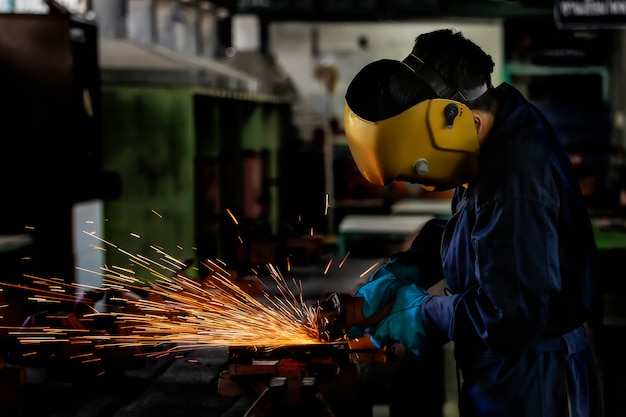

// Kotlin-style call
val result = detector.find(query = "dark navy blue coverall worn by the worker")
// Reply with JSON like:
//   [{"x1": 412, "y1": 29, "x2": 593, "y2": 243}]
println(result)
[{"x1": 421, "y1": 83, "x2": 603, "y2": 417}]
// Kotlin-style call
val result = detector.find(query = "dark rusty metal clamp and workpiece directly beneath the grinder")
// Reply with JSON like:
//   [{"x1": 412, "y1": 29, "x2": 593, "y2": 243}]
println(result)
[{"x1": 218, "y1": 341, "x2": 380, "y2": 417}]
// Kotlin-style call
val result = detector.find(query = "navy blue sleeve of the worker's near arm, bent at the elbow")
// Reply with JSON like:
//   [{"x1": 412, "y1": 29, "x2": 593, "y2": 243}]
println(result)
[{"x1": 422, "y1": 200, "x2": 560, "y2": 350}]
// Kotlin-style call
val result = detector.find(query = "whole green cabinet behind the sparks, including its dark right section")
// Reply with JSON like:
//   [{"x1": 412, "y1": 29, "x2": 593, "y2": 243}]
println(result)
[{"x1": 102, "y1": 84, "x2": 291, "y2": 276}]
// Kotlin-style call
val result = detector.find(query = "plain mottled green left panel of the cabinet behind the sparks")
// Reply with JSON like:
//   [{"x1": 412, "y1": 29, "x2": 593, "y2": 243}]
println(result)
[{"x1": 102, "y1": 85, "x2": 195, "y2": 272}]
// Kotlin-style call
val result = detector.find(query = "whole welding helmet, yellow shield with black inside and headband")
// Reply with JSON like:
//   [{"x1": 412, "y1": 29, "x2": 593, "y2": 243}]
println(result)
[{"x1": 344, "y1": 54, "x2": 488, "y2": 191}]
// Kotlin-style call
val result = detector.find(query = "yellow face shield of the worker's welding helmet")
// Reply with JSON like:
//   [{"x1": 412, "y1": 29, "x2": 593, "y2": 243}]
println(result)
[{"x1": 344, "y1": 58, "x2": 480, "y2": 191}]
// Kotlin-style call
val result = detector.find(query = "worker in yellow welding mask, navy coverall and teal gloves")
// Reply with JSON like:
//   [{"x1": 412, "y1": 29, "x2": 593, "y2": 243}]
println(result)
[{"x1": 344, "y1": 28, "x2": 603, "y2": 417}]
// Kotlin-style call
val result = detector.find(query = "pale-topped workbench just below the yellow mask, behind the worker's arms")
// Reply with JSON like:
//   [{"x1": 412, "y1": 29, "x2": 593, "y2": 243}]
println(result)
[{"x1": 337, "y1": 214, "x2": 434, "y2": 257}]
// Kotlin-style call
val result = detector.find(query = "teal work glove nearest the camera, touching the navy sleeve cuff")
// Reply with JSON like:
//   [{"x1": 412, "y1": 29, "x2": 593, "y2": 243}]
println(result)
[{"x1": 368, "y1": 285, "x2": 429, "y2": 355}]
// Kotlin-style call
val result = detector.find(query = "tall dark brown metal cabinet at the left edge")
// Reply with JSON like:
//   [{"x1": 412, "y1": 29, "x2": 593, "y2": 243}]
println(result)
[{"x1": 0, "y1": 13, "x2": 107, "y2": 292}]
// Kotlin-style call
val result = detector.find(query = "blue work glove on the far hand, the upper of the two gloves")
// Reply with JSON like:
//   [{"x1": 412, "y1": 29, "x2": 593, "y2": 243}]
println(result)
[{"x1": 354, "y1": 258, "x2": 419, "y2": 318}]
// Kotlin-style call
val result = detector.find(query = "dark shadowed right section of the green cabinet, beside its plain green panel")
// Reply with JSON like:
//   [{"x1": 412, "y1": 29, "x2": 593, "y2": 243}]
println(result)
[{"x1": 194, "y1": 95, "x2": 291, "y2": 268}]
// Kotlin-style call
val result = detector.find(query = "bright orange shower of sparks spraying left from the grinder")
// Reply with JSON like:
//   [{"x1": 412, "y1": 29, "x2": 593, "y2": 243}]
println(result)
[{"x1": 0, "y1": 232, "x2": 332, "y2": 360}]
